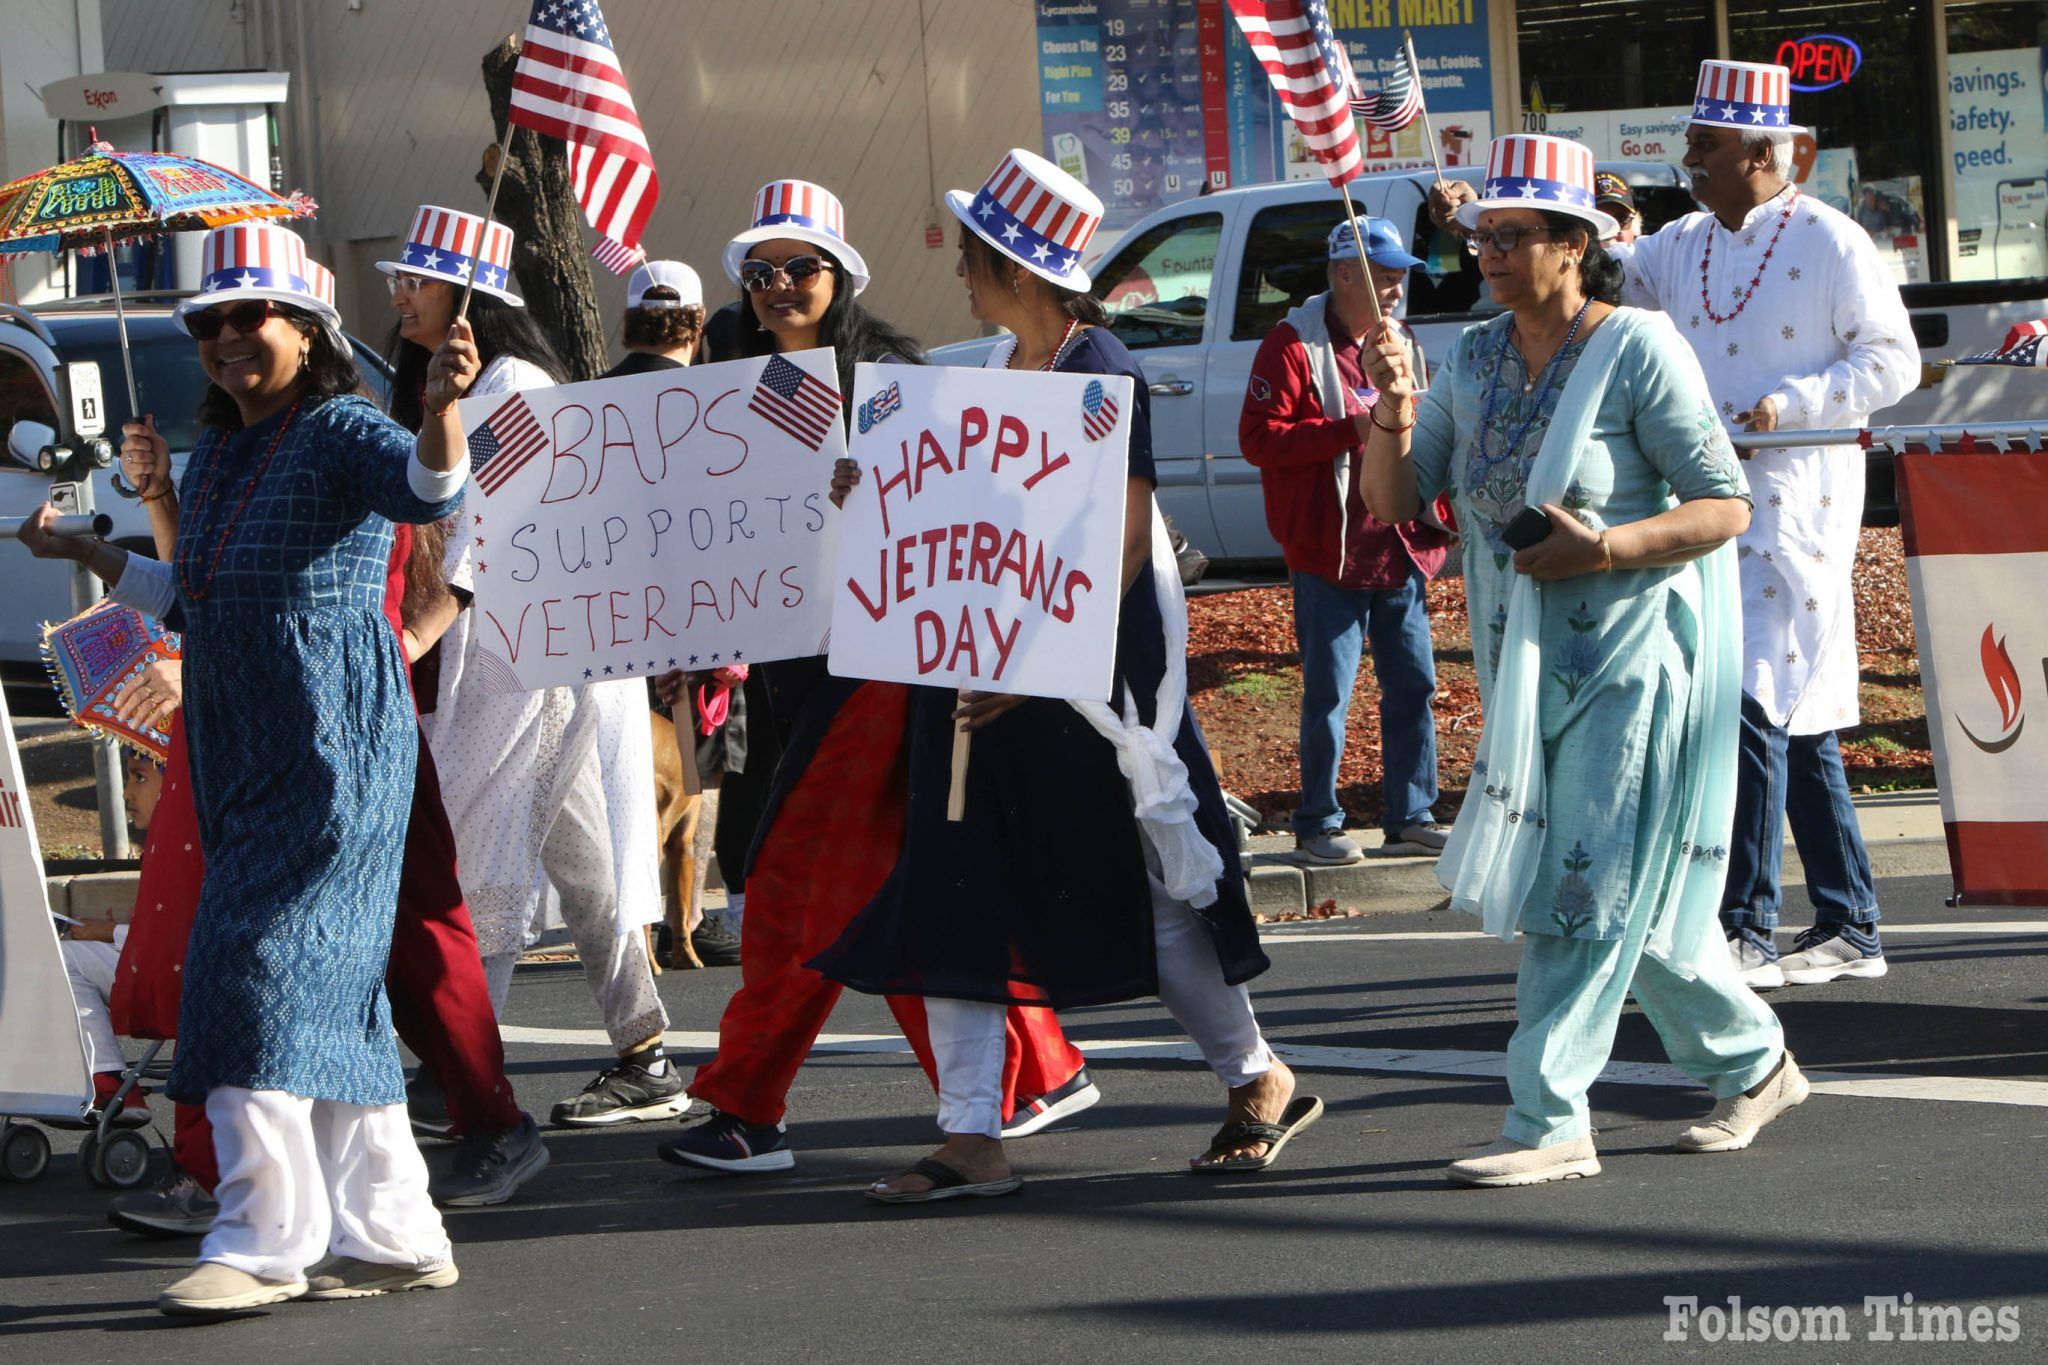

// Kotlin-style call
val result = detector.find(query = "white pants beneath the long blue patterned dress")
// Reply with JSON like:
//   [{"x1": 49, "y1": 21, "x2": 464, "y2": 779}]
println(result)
[{"x1": 199, "y1": 1085, "x2": 453, "y2": 1281}]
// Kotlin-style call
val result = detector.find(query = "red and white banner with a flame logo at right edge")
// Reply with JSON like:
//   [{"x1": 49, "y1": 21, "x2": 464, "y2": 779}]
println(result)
[{"x1": 1896, "y1": 450, "x2": 2048, "y2": 905}]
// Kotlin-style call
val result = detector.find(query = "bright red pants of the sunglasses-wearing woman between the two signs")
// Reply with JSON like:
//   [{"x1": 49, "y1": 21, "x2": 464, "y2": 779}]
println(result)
[{"x1": 690, "y1": 681, "x2": 1083, "y2": 1124}]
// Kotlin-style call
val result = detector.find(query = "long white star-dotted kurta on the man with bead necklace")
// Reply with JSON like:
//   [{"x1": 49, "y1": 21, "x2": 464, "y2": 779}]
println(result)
[{"x1": 1610, "y1": 190, "x2": 1919, "y2": 735}]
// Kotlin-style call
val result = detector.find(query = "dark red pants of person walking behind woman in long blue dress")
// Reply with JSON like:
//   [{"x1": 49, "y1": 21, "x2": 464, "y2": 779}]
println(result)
[{"x1": 172, "y1": 739, "x2": 520, "y2": 1189}]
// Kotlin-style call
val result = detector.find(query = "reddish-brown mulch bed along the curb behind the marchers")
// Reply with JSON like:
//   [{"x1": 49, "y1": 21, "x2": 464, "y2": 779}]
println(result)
[{"x1": 1188, "y1": 528, "x2": 1933, "y2": 827}]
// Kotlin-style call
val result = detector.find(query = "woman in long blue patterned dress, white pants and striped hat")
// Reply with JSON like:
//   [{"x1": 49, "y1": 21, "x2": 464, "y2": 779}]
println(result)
[{"x1": 18, "y1": 225, "x2": 467, "y2": 1314}]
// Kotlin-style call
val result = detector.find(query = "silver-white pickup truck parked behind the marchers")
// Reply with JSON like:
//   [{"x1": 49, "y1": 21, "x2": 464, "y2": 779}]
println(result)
[{"x1": 932, "y1": 162, "x2": 2048, "y2": 563}]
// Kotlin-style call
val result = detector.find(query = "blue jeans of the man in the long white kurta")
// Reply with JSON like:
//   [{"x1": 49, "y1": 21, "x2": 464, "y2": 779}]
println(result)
[{"x1": 1720, "y1": 692, "x2": 1878, "y2": 933}]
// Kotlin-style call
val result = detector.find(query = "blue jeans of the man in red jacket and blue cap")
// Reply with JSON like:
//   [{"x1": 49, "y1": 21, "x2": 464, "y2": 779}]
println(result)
[{"x1": 1290, "y1": 565, "x2": 1436, "y2": 837}]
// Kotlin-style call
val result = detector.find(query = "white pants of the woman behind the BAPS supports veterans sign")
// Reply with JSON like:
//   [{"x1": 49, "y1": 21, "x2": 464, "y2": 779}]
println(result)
[{"x1": 483, "y1": 740, "x2": 668, "y2": 1050}]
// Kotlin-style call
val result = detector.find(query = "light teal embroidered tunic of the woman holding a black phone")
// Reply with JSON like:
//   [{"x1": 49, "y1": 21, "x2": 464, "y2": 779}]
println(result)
[{"x1": 1411, "y1": 309, "x2": 1749, "y2": 939}]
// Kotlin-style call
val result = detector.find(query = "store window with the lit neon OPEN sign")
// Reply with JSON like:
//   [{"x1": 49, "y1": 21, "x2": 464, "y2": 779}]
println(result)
[{"x1": 1729, "y1": 0, "x2": 1933, "y2": 284}]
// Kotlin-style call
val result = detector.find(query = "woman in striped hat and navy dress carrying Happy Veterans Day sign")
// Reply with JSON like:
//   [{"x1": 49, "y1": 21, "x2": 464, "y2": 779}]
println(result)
[{"x1": 817, "y1": 149, "x2": 1323, "y2": 1203}]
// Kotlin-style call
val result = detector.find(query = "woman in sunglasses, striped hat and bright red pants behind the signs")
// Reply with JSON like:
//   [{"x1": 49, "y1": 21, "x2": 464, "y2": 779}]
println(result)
[{"x1": 657, "y1": 180, "x2": 1098, "y2": 1173}]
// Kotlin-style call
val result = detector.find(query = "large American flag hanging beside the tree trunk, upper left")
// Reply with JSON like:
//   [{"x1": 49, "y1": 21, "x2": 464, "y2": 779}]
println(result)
[{"x1": 510, "y1": 0, "x2": 662, "y2": 248}]
